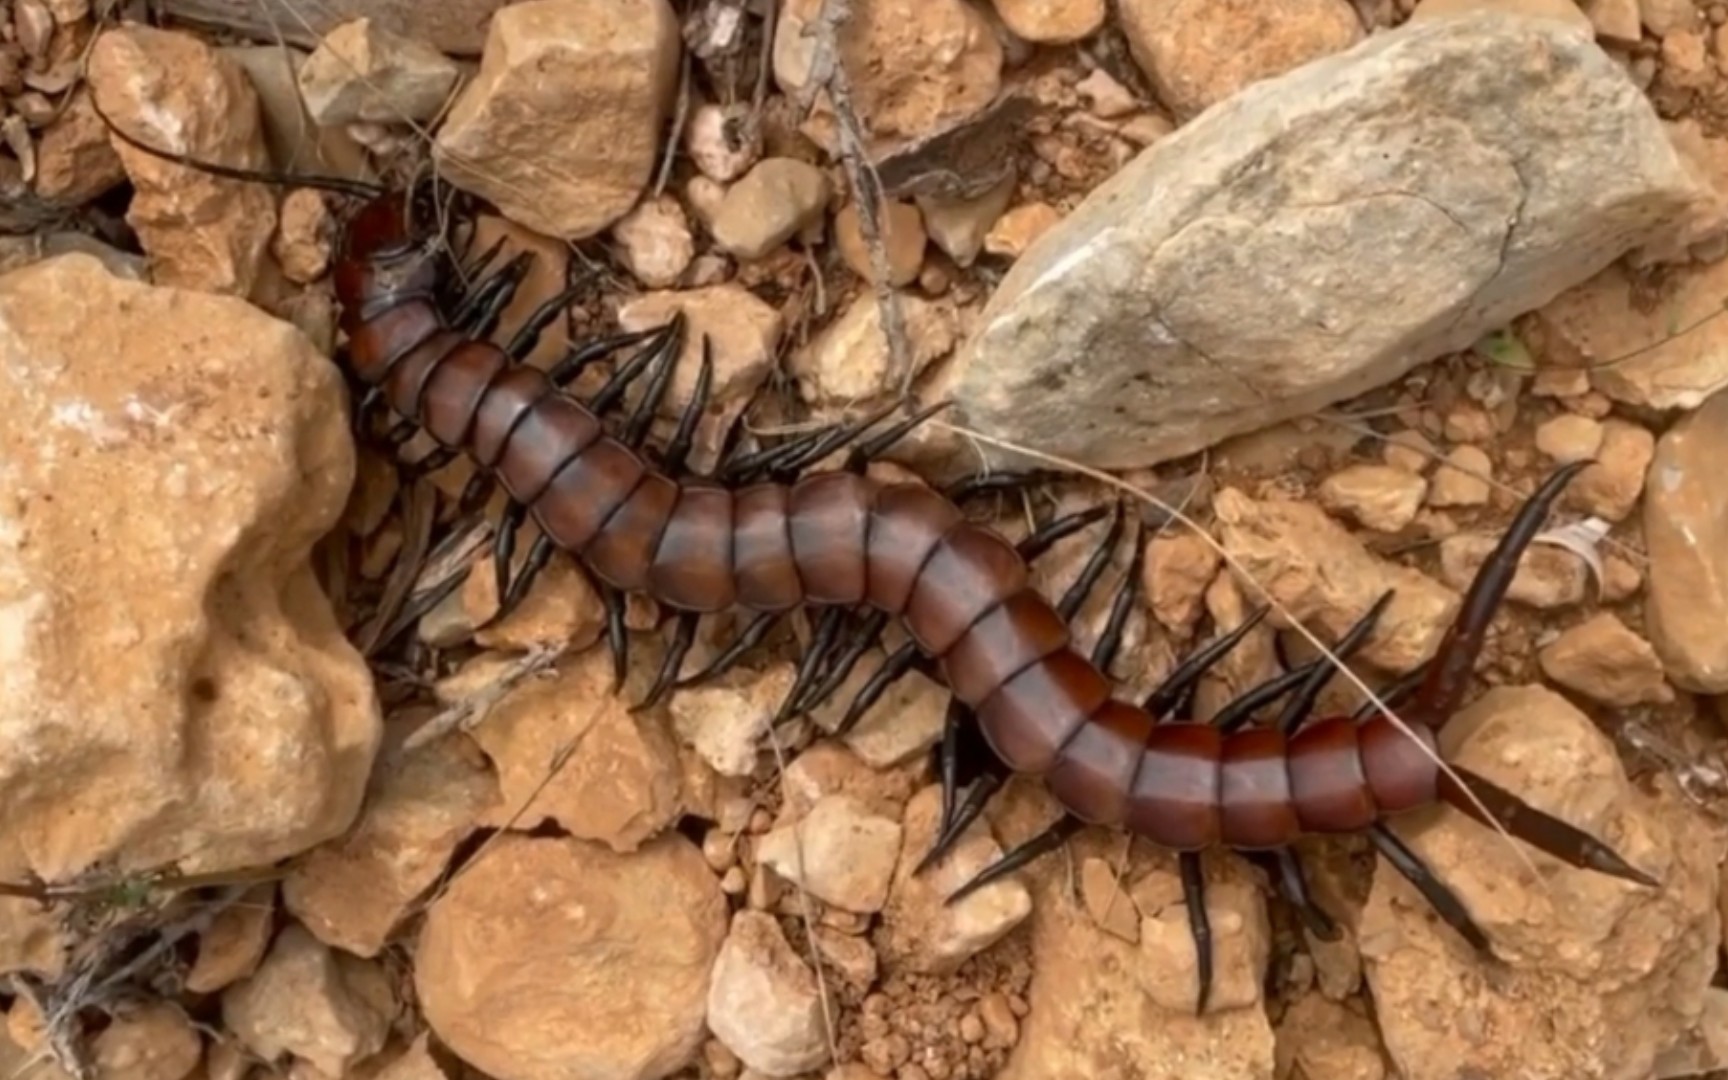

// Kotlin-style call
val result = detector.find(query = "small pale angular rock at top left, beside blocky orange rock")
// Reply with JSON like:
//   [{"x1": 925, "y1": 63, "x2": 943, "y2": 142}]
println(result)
[{"x1": 299, "y1": 17, "x2": 460, "y2": 126}]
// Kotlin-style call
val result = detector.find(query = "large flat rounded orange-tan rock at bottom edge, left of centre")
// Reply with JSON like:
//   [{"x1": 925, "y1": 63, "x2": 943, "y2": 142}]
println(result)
[{"x1": 415, "y1": 833, "x2": 726, "y2": 1080}]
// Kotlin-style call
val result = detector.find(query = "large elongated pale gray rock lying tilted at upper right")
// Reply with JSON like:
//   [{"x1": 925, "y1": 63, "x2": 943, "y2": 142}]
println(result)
[{"x1": 947, "y1": 12, "x2": 1707, "y2": 468}]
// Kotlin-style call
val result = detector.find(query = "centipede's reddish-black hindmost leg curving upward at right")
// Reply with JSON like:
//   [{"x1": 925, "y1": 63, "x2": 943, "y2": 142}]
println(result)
[{"x1": 1405, "y1": 458, "x2": 1595, "y2": 731}]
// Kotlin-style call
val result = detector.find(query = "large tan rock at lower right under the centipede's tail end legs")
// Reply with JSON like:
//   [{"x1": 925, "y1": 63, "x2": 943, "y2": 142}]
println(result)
[{"x1": 1360, "y1": 686, "x2": 1721, "y2": 1080}]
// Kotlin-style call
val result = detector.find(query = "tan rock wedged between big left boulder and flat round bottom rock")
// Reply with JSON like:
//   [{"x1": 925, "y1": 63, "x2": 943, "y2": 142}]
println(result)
[{"x1": 282, "y1": 736, "x2": 499, "y2": 957}]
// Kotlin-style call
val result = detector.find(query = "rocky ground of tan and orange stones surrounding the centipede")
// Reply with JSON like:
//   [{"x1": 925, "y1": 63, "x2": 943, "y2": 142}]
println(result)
[{"x1": 0, "y1": 0, "x2": 1728, "y2": 1080}]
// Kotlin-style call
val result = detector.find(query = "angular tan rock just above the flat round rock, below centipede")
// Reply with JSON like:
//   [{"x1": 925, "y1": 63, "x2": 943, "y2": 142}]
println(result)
[{"x1": 439, "y1": 648, "x2": 683, "y2": 852}]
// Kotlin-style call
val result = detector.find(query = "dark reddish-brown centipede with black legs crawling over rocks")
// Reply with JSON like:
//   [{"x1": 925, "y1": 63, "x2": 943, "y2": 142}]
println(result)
[{"x1": 94, "y1": 98, "x2": 1659, "y2": 1013}]
